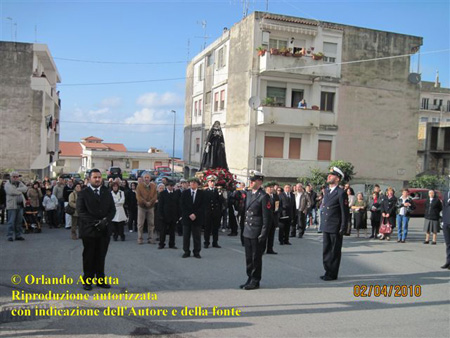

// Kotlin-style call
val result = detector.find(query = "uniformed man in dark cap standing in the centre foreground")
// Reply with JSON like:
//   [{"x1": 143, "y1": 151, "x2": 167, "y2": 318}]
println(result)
[{"x1": 240, "y1": 171, "x2": 272, "y2": 290}]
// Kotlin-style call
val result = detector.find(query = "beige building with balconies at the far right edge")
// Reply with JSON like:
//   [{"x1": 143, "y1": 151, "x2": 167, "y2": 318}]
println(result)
[{"x1": 417, "y1": 74, "x2": 450, "y2": 175}]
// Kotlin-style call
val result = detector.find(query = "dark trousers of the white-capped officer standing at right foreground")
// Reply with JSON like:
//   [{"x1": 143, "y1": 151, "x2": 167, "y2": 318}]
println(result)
[{"x1": 323, "y1": 232, "x2": 342, "y2": 278}]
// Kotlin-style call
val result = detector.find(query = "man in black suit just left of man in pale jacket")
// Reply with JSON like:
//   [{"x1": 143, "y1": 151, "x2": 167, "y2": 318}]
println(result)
[{"x1": 278, "y1": 184, "x2": 295, "y2": 245}]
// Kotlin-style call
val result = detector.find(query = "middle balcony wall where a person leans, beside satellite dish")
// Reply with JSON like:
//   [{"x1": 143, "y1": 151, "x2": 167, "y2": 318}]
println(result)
[{"x1": 257, "y1": 106, "x2": 336, "y2": 128}]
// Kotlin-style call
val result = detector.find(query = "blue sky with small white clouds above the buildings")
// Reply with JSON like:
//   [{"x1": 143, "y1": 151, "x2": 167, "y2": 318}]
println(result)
[{"x1": 0, "y1": 0, "x2": 450, "y2": 157}]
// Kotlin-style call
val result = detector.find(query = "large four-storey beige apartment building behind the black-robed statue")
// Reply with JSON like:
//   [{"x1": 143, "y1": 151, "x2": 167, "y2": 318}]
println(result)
[{"x1": 184, "y1": 12, "x2": 422, "y2": 186}]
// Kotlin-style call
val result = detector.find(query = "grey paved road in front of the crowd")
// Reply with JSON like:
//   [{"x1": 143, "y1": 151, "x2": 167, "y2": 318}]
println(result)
[{"x1": 0, "y1": 218, "x2": 450, "y2": 337}]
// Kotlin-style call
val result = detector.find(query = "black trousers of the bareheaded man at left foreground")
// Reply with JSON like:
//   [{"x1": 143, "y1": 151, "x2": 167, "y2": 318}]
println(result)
[{"x1": 83, "y1": 236, "x2": 110, "y2": 279}]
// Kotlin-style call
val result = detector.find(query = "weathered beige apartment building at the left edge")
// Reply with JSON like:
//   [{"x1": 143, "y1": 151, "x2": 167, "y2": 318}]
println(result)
[{"x1": 0, "y1": 41, "x2": 61, "y2": 178}]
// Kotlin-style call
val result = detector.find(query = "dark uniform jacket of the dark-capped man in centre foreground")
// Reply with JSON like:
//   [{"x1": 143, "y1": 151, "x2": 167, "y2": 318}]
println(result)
[{"x1": 244, "y1": 188, "x2": 272, "y2": 240}]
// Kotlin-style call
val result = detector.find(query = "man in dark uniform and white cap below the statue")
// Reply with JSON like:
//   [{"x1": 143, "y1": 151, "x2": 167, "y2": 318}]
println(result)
[{"x1": 203, "y1": 175, "x2": 225, "y2": 249}]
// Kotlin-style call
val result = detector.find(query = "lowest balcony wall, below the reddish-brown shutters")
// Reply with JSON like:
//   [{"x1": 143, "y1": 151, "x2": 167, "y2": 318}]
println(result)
[{"x1": 261, "y1": 157, "x2": 330, "y2": 177}]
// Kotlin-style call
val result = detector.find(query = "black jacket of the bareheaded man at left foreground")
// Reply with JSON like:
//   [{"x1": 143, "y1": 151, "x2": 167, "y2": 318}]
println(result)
[{"x1": 77, "y1": 186, "x2": 116, "y2": 238}]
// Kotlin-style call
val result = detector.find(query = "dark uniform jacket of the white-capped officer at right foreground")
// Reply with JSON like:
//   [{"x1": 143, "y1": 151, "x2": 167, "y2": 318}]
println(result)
[{"x1": 321, "y1": 187, "x2": 349, "y2": 234}]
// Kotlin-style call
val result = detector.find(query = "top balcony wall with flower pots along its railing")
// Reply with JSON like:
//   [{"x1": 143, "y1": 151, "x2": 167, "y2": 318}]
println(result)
[{"x1": 259, "y1": 51, "x2": 341, "y2": 78}]
